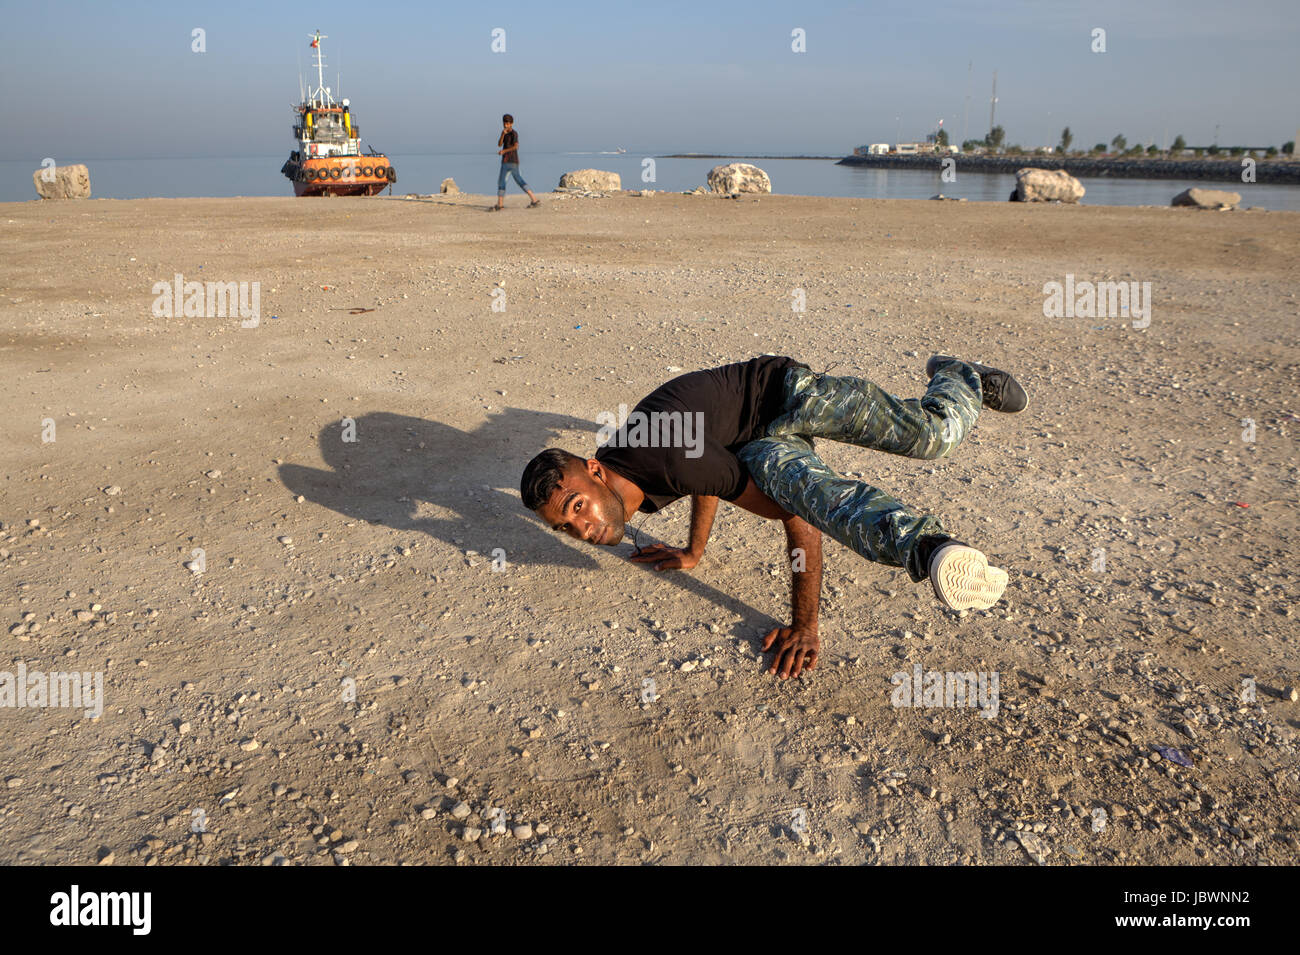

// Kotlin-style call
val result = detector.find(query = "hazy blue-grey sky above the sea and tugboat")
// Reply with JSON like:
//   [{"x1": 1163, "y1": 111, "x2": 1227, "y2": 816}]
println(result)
[{"x1": 0, "y1": 0, "x2": 1300, "y2": 161}]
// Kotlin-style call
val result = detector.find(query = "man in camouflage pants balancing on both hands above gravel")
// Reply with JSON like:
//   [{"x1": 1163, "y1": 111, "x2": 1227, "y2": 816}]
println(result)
[{"x1": 520, "y1": 355, "x2": 1028, "y2": 680}]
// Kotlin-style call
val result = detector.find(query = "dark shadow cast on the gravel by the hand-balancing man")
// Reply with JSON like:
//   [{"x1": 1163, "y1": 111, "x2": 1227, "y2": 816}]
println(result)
[{"x1": 280, "y1": 408, "x2": 768, "y2": 620}]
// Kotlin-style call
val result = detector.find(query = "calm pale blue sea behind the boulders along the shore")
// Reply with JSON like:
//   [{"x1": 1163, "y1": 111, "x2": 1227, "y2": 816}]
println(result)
[{"x1": 0, "y1": 147, "x2": 1300, "y2": 210}]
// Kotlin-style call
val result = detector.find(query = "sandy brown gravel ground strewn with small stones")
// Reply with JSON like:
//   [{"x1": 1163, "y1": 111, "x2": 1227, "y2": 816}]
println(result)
[{"x1": 0, "y1": 194, "x2": 1300, "y2": 865}]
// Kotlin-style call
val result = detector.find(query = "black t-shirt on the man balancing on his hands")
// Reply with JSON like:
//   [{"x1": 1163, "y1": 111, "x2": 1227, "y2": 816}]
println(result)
[{"x1": 595, "y1": 355, "x2": 807, "y2": 513}]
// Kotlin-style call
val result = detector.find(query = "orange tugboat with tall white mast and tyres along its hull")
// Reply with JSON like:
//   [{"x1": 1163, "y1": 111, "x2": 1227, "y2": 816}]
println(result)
[{"x1": 280, "y1": 30, "x2": 398, "y2": 196}]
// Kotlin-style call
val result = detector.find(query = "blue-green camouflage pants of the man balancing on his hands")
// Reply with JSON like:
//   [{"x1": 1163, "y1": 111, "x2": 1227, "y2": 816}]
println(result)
[{"x1": 737, "y1": 361, "x2": 982, "y2": 581}]
